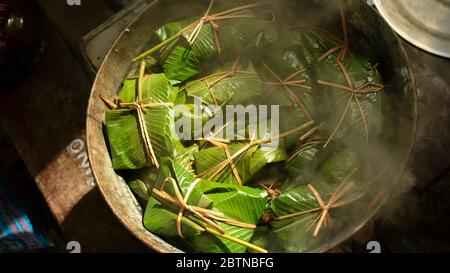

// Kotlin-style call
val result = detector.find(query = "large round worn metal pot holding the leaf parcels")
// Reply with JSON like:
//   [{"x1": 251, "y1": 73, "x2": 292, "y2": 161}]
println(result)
[{"x1": 87, "y1": 0, "x2": 417, "y2": 252}]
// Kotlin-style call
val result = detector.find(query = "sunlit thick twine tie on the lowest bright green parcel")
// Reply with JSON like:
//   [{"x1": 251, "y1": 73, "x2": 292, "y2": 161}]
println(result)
[{"x1": 152, "y1": 177, "x2": 256, "y2": 239}]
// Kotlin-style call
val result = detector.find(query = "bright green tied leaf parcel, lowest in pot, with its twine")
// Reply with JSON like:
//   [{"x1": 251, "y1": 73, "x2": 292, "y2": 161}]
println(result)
[{"x1": 144, "y1": 159, "x2": 267, "y2": 253}]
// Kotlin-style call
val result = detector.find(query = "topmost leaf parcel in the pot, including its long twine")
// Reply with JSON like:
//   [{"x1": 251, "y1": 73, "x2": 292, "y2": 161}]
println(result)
[{"x1": 136, "y1": 1, "x2": 270, "y2": 85}]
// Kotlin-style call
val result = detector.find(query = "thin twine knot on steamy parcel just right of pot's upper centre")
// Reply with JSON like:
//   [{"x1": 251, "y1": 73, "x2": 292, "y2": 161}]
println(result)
[{"x1": 263, "y1": 62, "x2": 314, "y2": 120}]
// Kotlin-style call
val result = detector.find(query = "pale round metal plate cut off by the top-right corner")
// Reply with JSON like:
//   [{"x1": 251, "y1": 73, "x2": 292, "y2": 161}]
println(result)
[{"x1": 375, "y1": 0, "x2": 450, "y2": 58}]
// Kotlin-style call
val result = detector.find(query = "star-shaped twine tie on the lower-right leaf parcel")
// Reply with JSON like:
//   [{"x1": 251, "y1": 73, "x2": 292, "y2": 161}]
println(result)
[{"x1": 275, "y1": 169, "x2": 364, "y2": 237}]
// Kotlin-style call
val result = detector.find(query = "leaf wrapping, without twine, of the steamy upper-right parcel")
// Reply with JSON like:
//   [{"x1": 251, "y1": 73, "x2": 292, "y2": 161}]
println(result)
[{"x1": 315, "y1": 56, "x2": 385, "y2": 145}]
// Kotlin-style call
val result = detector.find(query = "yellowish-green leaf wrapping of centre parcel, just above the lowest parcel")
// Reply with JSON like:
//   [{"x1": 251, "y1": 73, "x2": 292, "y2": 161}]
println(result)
[{"x1": 194, "y1": 143, "x2": 287, "y2": 184}]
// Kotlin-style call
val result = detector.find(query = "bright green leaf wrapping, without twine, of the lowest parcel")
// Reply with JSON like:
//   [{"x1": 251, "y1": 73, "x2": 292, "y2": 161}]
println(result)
[{"x1": 144, "y1": 159, "x2": 267, "y2": 253}]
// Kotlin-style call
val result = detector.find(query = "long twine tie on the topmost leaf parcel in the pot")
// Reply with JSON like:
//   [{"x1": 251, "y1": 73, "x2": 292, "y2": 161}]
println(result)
[{"x1": 133, "y1": 0, "x2": 275, "y2": 62}]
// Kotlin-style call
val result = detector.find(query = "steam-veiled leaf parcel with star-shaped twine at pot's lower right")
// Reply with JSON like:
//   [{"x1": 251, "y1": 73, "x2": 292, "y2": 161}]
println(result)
[{"x1": 271, "y1": 151, "x2": 364, "y2": 252}]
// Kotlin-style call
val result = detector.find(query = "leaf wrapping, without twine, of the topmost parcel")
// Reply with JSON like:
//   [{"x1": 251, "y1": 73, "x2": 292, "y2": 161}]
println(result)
[{"x1": 156, "y1": 7, "x2": 267, "y2": 85}]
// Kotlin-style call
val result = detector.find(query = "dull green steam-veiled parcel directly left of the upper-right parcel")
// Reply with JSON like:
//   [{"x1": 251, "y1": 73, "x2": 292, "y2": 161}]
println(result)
[{"x1": 250, "y1": 28, "x2": 314, "y2": 151}]
